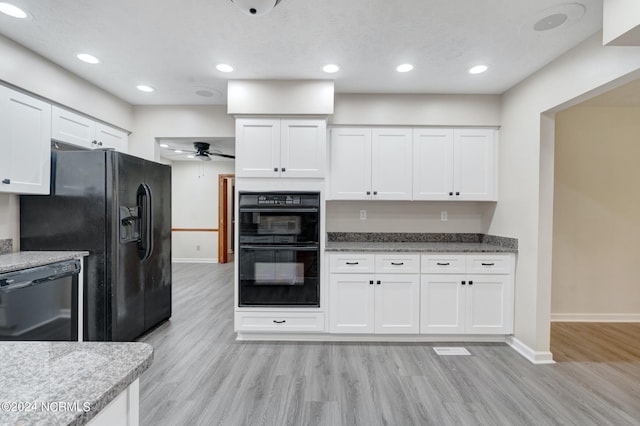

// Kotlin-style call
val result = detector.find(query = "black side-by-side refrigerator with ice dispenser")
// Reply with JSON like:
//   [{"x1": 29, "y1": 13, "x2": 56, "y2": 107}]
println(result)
[{"x1": 20, "y1": 150, "x2": 171, "y2": 341}]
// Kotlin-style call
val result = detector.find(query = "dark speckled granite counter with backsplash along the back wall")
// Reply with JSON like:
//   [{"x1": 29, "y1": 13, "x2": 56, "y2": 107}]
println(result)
[{"x1": 325, "y1": 232, "x2": 518, "y2": 253}]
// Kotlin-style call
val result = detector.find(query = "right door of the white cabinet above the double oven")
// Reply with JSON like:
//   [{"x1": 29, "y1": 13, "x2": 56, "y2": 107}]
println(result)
[{"x1": 280, "y1": 120, "x2": 327, "y2": 178}]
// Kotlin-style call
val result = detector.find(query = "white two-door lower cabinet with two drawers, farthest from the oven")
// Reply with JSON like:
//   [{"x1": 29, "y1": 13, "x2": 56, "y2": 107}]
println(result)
[{"x1": 420, "y1": 254, "x2": 513, "y2": 334}]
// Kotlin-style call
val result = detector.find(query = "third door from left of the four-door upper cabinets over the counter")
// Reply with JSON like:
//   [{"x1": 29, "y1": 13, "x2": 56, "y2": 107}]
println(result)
[{"x1": 413, "y1": 129, "x2": 453, "y2": 200}]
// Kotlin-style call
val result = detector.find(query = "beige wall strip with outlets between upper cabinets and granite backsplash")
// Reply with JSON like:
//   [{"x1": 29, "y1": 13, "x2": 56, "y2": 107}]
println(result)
[{"x1": 327, "y1": 201, "x2": 496, "y2": 234}]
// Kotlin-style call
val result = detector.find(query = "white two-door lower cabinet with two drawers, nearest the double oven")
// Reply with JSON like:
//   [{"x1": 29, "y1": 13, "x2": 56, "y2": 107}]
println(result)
[{"x1": 329, "y1": 254, "x2": 420, "y2": 334}]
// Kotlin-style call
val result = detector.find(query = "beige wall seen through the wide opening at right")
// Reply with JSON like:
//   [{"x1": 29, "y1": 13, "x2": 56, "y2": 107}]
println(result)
[{"x1": 551, "y1": 106, "x2": 640, "y2": 320}]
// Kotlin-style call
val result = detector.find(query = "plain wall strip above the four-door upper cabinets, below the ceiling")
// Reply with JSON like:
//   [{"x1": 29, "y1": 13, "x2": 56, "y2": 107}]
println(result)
[{"x1": 329, "y1": 94, "x2": 501, "y2": 127}]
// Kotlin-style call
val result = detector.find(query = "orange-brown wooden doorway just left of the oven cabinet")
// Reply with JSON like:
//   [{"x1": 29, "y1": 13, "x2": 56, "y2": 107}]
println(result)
[{"x1": 218, "y1": 174, "x2": 236, "y2": 263}]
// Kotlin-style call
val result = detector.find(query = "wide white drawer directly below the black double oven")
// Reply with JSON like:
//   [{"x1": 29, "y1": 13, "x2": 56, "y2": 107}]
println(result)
[{"x1": 235, "y1": 312, "x2": 324, "y2": 333}]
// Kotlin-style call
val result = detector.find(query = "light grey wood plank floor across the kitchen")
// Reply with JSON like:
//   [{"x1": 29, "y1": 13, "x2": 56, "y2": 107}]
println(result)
[{"x1": 140, "y1": 264, "x2": 640, "y2": 426}]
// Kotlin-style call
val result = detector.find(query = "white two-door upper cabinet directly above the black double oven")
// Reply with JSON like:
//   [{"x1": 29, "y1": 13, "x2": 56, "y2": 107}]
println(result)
[{"x1": 236, "y1": 118, "x2": 327, "y2": 178}]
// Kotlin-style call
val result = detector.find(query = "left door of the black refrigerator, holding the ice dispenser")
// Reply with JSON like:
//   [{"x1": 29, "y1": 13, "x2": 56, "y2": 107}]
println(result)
[{"x1": 114, "y1": 152, "x2": 144, "y2": 341}]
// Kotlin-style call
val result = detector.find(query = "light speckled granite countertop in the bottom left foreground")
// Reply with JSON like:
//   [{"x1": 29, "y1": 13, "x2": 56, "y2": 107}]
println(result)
[{"x1": 0, "y1": 342, "x2": 153, "y2": 425}]
